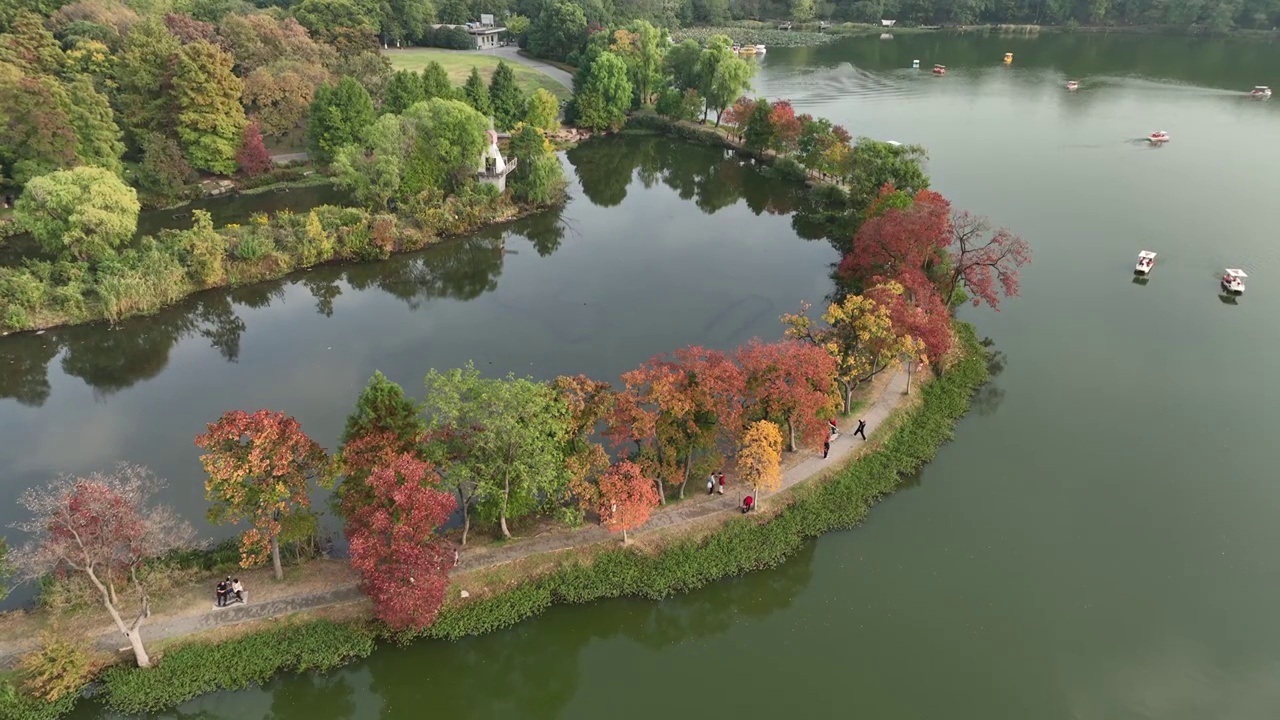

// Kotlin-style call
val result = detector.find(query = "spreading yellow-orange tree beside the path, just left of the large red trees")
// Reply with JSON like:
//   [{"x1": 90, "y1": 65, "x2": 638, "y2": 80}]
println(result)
[{"x1": 782, "y1": 282, "x2": 922, "y2": 414}]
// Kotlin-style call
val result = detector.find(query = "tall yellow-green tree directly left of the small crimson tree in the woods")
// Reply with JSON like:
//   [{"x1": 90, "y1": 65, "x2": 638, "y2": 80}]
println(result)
[{"x1": 173, "y1": 40, "x2": 246, "y2": 176}]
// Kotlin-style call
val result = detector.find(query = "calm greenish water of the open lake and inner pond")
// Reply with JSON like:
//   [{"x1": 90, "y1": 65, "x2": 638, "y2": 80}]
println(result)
[{"x1": 22, "y1": 36, "x2": 1280, "y2": 720}]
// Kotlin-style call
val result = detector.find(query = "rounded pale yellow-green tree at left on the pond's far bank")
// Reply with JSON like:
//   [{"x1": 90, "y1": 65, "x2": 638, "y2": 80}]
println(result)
[{"x1": 14, "y1": 168, "x2": 141, "y2": 263}]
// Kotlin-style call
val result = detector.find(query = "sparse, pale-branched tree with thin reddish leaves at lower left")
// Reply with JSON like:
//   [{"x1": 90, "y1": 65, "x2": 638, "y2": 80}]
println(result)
[{"x1": 14, "y1": 464, "x2": 195, "y2": 667}]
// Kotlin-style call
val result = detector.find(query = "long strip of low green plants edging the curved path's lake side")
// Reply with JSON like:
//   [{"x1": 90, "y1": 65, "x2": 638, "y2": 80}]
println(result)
[{"x1": 0, "y1": 323, "x2": 988, "y2": 720}]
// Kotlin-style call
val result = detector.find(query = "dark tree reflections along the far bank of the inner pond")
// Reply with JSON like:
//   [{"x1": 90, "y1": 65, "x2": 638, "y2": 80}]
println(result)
[{"x1": 0, "y1": 136, "x2": 838, "y2": 407}]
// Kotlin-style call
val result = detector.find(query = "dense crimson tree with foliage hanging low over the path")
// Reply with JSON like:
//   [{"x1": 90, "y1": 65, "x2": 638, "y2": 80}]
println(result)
[{"x1": 346, "y1": 454, "x2": 458, "y2": 630}]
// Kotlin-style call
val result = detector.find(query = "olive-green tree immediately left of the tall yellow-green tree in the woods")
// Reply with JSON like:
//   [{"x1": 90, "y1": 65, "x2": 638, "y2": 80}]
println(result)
[{"x1": 115, "y1": 18, "x2": 180, "y2": 146}]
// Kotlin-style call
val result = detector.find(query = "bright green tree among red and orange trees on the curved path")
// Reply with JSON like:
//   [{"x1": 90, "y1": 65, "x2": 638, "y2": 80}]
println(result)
[{"x1": 424, "y1": 363, "x2": 570, "y2": 543}]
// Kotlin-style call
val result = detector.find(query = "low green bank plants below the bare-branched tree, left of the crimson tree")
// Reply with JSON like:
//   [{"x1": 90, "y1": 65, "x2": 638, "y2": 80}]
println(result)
[{"x1": 102, "y1": 620, "x2": 374, "y2": 715}]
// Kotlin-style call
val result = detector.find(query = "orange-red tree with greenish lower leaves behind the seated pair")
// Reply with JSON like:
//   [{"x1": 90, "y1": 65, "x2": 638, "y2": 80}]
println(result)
[{"x1": 196, "y1": 410, "x2": 329, "y2": 580}]
